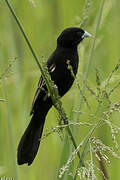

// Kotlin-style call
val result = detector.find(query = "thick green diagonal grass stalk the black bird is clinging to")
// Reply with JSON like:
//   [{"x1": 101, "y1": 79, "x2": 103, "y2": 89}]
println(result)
[{"x1": 5, "y1": 0, "x2": 80, "y2": 159}]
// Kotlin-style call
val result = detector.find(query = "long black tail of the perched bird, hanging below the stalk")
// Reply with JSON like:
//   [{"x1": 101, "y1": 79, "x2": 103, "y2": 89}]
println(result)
[{"x1": 17, "y1": 107, "x2": 50, "y2": 165}]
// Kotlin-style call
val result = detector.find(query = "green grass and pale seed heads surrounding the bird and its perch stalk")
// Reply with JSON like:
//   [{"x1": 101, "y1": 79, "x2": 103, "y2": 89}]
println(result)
[{"x1": 0, "y1": 0, "x2": 120, "y2": 180}]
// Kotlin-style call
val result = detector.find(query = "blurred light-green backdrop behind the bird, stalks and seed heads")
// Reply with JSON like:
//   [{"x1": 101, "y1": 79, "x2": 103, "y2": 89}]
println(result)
[{"x1": 0, "y1": 0, "x2": 120, "y2": 180}]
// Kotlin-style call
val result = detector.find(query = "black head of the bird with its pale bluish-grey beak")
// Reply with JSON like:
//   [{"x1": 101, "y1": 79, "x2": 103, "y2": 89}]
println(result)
[{"x1": 57, "y1": 27, "x2": 91, "y2": 48}]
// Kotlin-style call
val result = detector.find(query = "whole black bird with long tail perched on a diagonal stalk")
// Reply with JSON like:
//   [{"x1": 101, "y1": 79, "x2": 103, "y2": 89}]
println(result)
[{"x1": 17, "y1": 27, "x2": 91, "y2": 165}]
